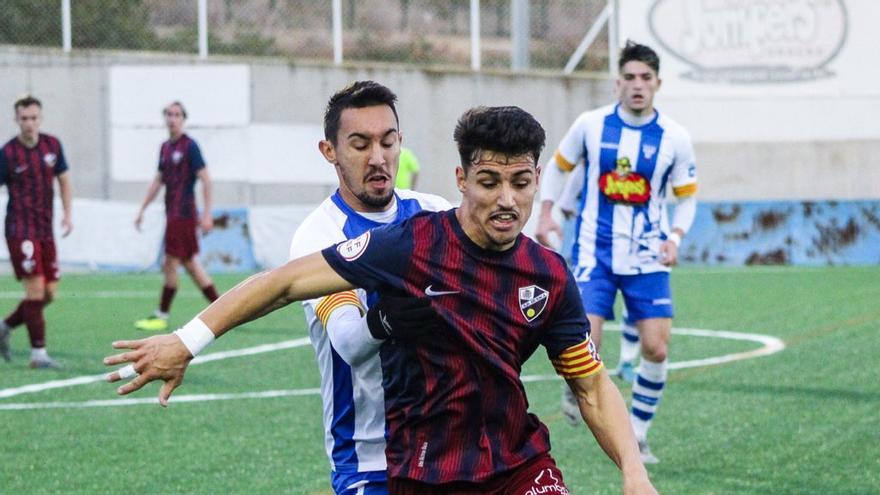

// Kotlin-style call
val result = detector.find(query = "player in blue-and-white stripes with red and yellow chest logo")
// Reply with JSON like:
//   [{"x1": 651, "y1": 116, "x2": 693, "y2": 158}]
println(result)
[{"x1": 536, "y1": 42, "x2": 697, "y2": 463}]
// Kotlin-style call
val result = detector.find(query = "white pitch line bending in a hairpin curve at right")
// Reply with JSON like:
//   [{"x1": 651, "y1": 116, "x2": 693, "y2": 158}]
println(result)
[{"x1": 0, "y1": 325, "x2": 785, "y2": 411}]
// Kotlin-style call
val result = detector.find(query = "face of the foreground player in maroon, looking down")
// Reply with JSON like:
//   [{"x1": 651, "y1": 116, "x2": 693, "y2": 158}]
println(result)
[{"x1": 455, "y1": 151, "x2": 538, "y2": 251}]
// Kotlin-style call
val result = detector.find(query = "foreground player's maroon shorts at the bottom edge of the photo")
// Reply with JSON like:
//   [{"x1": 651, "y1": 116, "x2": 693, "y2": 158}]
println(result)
[{"x1": 388, "y1": 453, "x2": 569, "y2": 495}]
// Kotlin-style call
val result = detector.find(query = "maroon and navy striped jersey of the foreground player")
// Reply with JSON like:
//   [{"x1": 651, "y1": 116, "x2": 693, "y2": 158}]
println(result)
[{"x1": 323, "y1": 210, "x2": 589, "y2": 484}]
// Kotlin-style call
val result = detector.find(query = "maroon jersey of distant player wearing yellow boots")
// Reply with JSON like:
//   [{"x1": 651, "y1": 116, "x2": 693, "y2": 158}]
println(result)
[{"x1": 159, "y1": 134, "x2": 205, "y2": 218}]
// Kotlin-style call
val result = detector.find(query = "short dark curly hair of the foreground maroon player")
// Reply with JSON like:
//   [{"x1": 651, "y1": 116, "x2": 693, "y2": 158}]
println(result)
[{"x1": 453, "y1": 106, "x2": 546, "y2": 172}]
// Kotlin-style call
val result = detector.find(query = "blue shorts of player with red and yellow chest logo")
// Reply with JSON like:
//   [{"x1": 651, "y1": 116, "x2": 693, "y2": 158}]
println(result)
[{"x1": 578, "y1": 268, "x2": 673, "y2": 322}]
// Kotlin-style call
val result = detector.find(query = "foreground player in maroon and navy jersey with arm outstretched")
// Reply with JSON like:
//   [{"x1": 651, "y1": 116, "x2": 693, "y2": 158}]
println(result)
[{"x1": 104, "y1": 107, "x2": 657, "y2": 495}]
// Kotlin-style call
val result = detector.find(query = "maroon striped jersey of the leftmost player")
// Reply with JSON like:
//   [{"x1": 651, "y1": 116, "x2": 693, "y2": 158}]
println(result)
[{"x1": 0, "y1": 134, "x2": 67, "y2": 241}]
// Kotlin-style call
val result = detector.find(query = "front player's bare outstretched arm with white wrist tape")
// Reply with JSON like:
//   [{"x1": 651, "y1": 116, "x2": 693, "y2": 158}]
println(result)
[{"x1": 104, "y1": 253, "x2": 354, "y2": 406}]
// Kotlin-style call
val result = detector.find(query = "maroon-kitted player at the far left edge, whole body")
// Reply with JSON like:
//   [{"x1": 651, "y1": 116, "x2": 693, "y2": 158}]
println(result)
[{"x1": 0, "y1": 96, "x2": 73, "y2": 368}]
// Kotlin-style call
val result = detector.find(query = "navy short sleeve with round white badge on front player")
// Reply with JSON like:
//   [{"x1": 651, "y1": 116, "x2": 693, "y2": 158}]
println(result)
[{"x1": 321, "y1": 221, "x2": 413, "y2": 292}]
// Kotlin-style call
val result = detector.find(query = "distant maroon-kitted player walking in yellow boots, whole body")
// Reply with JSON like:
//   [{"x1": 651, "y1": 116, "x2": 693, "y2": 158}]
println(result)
[{"x1": 134, "y1": 101, "x2": 217, "y2": 331}]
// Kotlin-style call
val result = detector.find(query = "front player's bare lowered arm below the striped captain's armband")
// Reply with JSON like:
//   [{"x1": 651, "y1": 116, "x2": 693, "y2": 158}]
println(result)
[{"x1": 566, "y1": 368, "x2": 657, "y2": 495}]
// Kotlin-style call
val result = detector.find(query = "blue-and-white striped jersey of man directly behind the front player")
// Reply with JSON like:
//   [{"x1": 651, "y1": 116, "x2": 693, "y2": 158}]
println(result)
[{"x1": 290, "y1": 189, "x2": 451, "y2": 473}]
